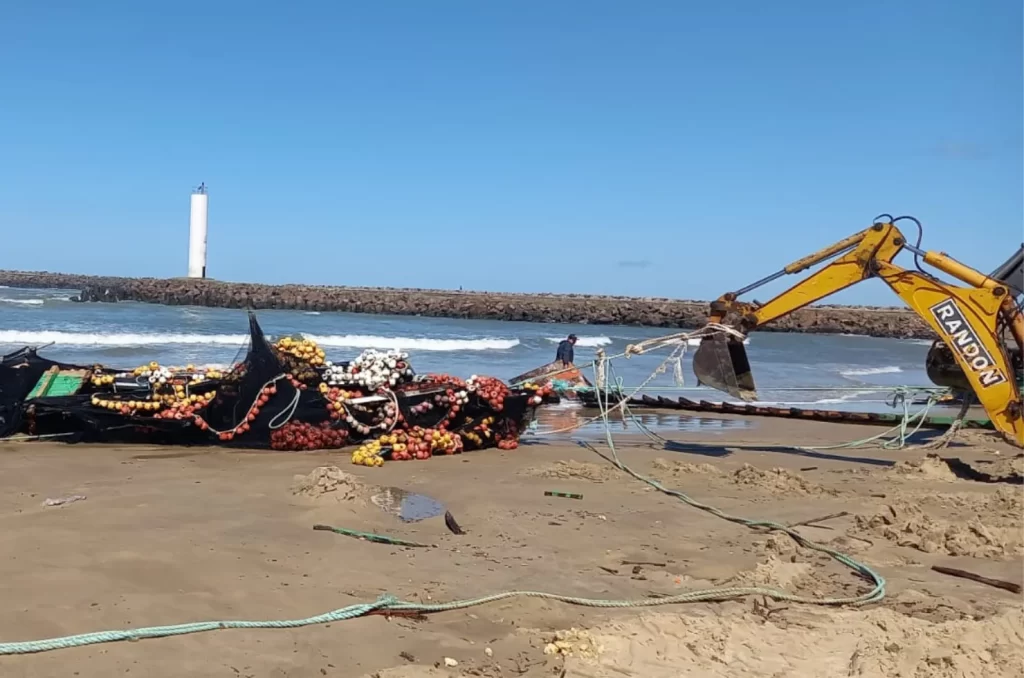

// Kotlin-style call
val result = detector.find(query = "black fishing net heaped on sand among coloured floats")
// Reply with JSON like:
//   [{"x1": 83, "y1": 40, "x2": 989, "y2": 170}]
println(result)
[{"x1": 0, "y1": 313, "x2": 531, "y2": 449}]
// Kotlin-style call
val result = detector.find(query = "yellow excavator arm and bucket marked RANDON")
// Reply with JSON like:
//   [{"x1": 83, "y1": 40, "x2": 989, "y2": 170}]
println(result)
[{"x1": 693, "y1": 214, "x2": 1024, "y2": 447}]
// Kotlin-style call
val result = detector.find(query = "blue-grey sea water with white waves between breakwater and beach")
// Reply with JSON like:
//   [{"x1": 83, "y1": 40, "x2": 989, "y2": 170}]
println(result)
[{"x1": 0, "y1": 288, "x2": 942, "y2": 436}]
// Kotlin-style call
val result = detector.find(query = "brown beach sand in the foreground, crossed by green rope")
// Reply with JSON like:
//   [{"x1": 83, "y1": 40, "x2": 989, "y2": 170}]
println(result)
[{"x1": 0, "y1": 421, "x2": 1024, "y2": 678}]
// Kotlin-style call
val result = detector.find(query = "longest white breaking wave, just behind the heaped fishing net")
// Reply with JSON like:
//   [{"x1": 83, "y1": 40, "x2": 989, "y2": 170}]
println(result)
[{"x1": 0, "y1": 330, "x2": 519, "y2": 351}]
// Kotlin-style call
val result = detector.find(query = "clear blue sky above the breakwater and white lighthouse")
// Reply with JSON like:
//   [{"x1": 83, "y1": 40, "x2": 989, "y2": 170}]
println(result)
[{"x1": 0, "y1": 0, "x2": 1024, "y2": 304}]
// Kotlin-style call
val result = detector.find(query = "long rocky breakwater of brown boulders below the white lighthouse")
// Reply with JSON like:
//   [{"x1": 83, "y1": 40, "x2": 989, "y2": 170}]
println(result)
[{"x1": 0, "y1": 271, "x2": 932, "y2": 338}]
